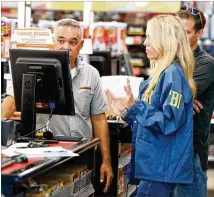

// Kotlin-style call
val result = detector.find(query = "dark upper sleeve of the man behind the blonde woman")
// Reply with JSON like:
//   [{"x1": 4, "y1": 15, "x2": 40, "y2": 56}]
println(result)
[{"x1": 193, "y1": 57, "x2": 214, "y2": 97}]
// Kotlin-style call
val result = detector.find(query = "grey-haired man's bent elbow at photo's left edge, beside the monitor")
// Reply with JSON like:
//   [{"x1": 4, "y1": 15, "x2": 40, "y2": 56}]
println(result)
[{"x1": 1, "y1": 96, "x2": 16, "y2": 118}]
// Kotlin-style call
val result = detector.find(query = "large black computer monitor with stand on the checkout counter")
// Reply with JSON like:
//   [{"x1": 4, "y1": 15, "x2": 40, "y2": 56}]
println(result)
[{"x1": 10, "y1": 49, "x2": 75, "y2": 136}]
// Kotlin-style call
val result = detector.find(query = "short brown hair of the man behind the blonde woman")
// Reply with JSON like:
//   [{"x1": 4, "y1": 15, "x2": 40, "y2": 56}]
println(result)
[{"x1": 177, "y1": 9, "x2": 206, "y2": 32}]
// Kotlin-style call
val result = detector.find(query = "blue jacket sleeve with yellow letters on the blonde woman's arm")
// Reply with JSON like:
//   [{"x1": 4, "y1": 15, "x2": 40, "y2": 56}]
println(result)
[{"x1": 123, "y1": 67, "x2": 193, "y2": 135}]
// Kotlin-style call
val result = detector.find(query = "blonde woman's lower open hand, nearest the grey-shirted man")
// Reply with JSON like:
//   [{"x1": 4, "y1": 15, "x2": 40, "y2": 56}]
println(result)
[{"x1": 105, "y1": 89, "x2": 125, "y2": 116}]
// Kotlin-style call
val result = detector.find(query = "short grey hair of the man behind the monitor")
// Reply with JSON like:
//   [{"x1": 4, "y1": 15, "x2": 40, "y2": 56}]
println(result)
[{"x1": 54, "y1": 18, "x2": 83, "y2": 39}]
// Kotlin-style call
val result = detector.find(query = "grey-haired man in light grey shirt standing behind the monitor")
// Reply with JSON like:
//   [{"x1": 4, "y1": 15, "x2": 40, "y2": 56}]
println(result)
[{"x1": 1, "y1": 19, "x2": 113, "y2": 192}]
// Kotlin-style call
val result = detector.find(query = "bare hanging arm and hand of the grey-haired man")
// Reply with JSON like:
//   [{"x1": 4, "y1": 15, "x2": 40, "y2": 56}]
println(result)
[{"x1": 91, "y1": 113, "x2": 113, "y2": 192}]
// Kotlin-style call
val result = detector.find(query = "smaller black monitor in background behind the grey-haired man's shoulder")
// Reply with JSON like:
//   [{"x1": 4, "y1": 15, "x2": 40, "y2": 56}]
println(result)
[{"x1": 89, "y1": 51, "x2": 112, "y2": 77}]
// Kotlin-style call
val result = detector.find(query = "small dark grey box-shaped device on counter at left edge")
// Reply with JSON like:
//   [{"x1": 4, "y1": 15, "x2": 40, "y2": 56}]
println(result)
[{"x1": 1, "y1": 118, "x2": 17, "y2": 146}]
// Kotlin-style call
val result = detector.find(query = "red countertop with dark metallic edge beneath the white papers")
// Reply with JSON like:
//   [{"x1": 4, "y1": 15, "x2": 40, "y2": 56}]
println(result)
[{"x1": 1, "y1": 138, "x2": 100, "y2": 184}]
